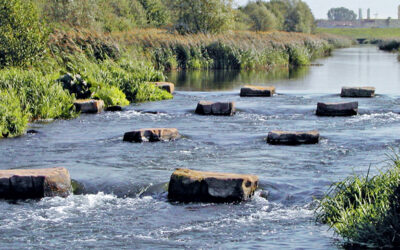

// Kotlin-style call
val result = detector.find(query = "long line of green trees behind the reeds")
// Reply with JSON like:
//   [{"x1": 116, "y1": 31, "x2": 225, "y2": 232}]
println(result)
[{"x1": 34, "y1": 0, "x2": 315, "y2": 34}]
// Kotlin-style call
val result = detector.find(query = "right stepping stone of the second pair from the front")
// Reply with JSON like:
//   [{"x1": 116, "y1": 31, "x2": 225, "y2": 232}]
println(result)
[{"x1": 267, "y1": 130, "x2": 319, "y2": 145}]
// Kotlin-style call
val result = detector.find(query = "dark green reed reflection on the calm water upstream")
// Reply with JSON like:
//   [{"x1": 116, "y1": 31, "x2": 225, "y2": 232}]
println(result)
[{"x1": 167, "y1": 67, "x2": 310, "y2": 91}]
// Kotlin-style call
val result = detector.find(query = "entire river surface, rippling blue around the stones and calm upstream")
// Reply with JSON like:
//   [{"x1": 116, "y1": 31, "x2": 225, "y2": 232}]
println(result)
[{"x1": 0, "y1": 47, "x2": 400, "y2": 249}]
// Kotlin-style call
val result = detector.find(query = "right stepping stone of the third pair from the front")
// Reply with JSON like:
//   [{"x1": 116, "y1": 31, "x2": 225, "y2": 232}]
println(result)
[{"x1": 317, "y1": 102, "x2": 358, "y2": 116}]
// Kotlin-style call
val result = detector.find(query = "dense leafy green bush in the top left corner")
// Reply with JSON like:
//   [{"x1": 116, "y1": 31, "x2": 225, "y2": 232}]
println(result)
[{"x1": 0, "y1": 0, "x2": 47, "y2": 68}]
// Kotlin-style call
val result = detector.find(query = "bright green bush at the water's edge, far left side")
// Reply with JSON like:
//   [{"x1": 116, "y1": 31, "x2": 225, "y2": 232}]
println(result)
[{"x1": 0, "y1": 89, "x2": 28, "y2": 137}]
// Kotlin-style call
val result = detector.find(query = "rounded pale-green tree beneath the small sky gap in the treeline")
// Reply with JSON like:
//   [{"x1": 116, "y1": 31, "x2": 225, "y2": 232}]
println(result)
[{"x1": 243, "y1": 2, "x2": 277, "y2": 31}]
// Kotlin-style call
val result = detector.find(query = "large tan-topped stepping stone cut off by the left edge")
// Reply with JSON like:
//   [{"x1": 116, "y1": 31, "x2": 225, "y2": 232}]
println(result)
[{"x1": 0, "y1": 168, "x2": 72, "y2": 199}]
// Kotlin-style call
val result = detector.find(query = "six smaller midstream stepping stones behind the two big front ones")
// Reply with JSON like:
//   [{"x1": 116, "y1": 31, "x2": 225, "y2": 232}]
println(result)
[{"x1": 123, "y1": 86, "x2": 375, "y2": 145}]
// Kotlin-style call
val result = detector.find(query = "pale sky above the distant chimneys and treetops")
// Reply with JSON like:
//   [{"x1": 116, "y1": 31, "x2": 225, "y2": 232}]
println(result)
[{"x1": 236, "y1": 0, "x2": 400, "y2": 19}]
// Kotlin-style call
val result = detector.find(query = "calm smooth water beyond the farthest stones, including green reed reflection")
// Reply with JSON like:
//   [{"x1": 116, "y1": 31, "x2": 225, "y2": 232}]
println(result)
[{"x1": 168, "y1": 46, "x2": 400, "y2": 95}]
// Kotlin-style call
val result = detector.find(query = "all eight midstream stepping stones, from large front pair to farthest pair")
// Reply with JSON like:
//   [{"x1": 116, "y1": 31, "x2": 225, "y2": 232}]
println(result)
[{"x1": 0, "y1": 86, "x2": 375, "y2": 202}]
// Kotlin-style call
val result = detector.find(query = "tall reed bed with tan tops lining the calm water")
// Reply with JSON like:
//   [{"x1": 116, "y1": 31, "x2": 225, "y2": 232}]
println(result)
[{"x1": 112, "y1": 29, "x2": 351, "y2": 70}]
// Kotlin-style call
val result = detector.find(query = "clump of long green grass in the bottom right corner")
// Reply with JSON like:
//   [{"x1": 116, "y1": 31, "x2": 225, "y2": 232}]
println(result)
[{"x1": 317, "y1": 155, "x2": 400, "y2": 248}]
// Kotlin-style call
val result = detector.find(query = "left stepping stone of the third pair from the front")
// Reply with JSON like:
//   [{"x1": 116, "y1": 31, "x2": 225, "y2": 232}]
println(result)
[{"x1": 195, "y1": 101, "x2": 236, "y2": 116}]
